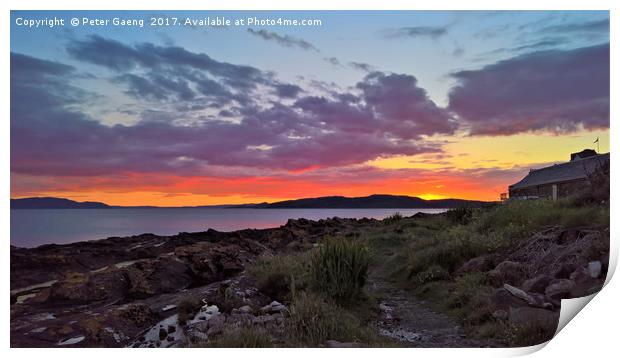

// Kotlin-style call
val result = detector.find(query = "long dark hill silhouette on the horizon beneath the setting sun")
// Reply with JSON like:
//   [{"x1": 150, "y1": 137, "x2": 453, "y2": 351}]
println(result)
[{"x1": 237, "y1": 194, "x2": 488, "y2": 209}]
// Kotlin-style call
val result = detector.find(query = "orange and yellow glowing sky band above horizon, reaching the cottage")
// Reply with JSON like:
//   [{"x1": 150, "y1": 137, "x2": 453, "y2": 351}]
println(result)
[{"x1": 11, "y1": 130, "x2": 609, "y2": 207}]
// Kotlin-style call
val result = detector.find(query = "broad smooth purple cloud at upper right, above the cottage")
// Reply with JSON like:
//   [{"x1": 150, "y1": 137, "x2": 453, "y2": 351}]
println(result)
[{"x1": 449, "y1": 44, "x2": 610, "y2": 135}]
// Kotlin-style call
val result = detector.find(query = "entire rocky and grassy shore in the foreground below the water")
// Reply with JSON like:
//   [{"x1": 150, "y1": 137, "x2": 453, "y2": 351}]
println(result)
[{"x1": 11, "y1": 201, "x2": 609, "y2": 347}]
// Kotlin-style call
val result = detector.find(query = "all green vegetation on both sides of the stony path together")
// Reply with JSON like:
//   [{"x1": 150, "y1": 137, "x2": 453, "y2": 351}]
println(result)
[{"x1": 243, "y1": 187, "x2": 609, "y2": 346}]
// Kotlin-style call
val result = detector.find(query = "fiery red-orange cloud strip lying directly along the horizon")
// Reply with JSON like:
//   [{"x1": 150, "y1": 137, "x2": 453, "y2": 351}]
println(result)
[{"x1": 11, "y1": 165, "x2": 528, "y2": 200}]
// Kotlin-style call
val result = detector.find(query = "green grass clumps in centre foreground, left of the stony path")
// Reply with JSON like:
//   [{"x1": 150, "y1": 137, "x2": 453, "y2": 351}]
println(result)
[{"x1": 249, "y1": 238, "x2": 378, "y2": 346}]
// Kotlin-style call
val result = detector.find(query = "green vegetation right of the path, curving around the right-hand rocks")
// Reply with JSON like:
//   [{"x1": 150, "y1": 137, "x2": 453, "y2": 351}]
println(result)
[{"x1": 406, "y1": 193, "x2": 609, "y2": 346}]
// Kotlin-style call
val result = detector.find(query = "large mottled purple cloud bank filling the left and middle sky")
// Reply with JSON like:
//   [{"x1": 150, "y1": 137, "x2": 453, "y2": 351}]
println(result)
[{"x1": 11, "y1": 44, "x2": 454, "y2": 177}]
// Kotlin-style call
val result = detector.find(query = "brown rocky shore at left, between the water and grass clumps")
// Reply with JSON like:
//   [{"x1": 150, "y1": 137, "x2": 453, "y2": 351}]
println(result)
[{"x1": 11, "y1": 218, "x2": 377, "y2": 347}]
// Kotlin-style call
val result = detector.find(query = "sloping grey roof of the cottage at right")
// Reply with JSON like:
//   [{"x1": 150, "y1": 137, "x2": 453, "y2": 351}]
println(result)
[{"x1": 508, "y1": 153, "x2": 609, "y2": 189}]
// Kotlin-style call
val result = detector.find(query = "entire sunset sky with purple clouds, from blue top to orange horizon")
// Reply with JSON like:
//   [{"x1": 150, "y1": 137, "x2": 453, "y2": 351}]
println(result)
[{"x1": 10, "y1": 11, "x2": 610, "y2": 206}]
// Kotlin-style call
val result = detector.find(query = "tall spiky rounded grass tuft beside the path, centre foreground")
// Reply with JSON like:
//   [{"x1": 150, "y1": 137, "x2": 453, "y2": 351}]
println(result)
[{"x1": 310, "y1": 238, "x2": 369, "y2": 302}]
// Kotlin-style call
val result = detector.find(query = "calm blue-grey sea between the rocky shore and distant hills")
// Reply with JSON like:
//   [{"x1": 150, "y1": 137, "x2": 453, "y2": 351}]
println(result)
[{"x1": 11, "y1": 208, "x2": 445, "y2": 247}]
